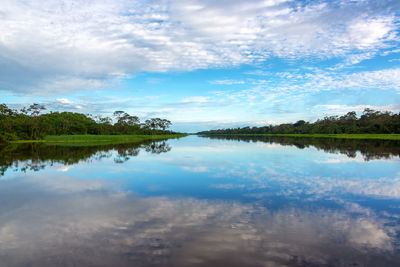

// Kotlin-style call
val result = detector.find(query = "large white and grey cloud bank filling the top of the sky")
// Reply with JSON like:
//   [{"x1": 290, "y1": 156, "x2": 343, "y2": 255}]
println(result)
[{"x1": 0, "y1": 0, "x2": 398, "y2": 94}]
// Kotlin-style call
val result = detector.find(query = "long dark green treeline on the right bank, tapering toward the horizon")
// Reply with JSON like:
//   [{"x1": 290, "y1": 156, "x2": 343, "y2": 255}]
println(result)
[{"x1": 198, "y1": 108, "x2": 400, "y2": 135}]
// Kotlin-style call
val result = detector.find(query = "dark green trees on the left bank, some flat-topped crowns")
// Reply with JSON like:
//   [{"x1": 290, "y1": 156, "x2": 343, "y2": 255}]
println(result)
[{"x1": 0, "y1": 103, "x2": 173, "y2": 143}]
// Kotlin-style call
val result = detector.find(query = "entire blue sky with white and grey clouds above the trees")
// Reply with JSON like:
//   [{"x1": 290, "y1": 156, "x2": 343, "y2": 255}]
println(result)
[{"x1": 0, "y1": 0, "x2": 400, "y2": 132}]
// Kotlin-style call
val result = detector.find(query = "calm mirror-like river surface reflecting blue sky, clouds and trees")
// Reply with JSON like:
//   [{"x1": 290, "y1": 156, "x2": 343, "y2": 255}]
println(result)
[{"x1": 0, "y1": 136, "x2": 400, "y2": 266}]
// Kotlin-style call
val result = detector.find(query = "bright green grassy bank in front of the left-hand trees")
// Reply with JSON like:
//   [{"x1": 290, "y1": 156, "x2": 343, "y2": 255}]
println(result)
[{"x1": 11, "y1": 134, "x2": 185, "y2": 144}]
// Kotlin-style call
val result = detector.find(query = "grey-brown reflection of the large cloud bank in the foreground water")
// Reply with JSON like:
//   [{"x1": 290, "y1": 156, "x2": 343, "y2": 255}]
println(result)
[{"x1": 0, "y1": 177, "x2": 399, "y2": 266}]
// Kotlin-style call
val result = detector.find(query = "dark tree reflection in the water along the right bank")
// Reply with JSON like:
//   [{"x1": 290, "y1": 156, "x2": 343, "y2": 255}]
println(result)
[{"x1": 205, "y1": 135, "x2": 400, "y2": 161}]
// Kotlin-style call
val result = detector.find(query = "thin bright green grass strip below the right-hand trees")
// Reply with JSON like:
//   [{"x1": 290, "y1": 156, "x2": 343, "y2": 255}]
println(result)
[{"x1": 200, "y1": 134, "x2": 400, "y2": 140}]
